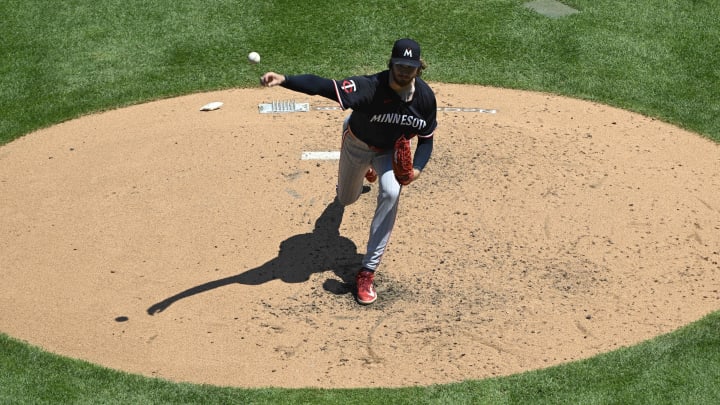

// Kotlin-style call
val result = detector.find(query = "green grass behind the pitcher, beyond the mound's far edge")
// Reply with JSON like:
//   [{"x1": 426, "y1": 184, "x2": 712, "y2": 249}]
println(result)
[{"x1": 0, "y1": 0, "x2": 720, "y2": 143}]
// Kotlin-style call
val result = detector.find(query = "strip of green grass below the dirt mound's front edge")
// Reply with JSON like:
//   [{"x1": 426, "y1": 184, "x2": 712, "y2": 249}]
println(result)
[{"x1": 0, "y1": 313, "x2": 720, "y2": 404}]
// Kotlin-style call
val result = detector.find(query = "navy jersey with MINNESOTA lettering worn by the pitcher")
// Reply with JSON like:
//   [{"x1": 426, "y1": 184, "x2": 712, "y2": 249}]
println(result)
[{"x1": 334, "y1": 70, "x2": 437, "y2": 149}]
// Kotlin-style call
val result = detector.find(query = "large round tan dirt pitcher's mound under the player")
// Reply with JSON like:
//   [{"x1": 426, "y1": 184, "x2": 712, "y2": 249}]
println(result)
[{"x1": 0, "y1": 83, "x2": 720, "y2": 387}]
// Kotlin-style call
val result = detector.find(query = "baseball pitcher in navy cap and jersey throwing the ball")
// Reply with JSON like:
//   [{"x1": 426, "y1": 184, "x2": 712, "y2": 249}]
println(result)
[{"x1": 260, "y1": 38, "x2": 437, "y2": 304}]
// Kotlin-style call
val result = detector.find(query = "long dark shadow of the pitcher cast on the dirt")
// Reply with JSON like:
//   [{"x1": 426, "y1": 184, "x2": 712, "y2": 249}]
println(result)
[{"x1": 147, "y1": 199, "x2": 362, "y2": 315}]
